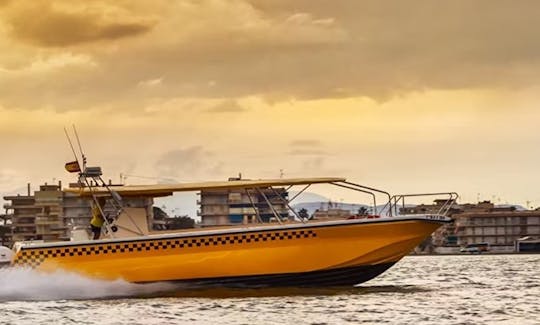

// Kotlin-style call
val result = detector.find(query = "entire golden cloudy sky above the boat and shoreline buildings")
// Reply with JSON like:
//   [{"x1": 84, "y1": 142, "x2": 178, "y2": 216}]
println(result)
[{"x1": 0, "y1": 0, "x2": 540, "y2": 207}]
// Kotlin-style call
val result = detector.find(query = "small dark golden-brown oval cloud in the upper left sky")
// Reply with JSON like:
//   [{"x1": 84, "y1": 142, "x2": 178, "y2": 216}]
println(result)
[{"x1": 7, "y1": 1, "x2": 153, "y2": 47}]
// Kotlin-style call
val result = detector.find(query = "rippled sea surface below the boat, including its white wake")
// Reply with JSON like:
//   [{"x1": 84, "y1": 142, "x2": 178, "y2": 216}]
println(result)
[{"x1": 0, "y1": 255, "x2": 540, "y2": 324}]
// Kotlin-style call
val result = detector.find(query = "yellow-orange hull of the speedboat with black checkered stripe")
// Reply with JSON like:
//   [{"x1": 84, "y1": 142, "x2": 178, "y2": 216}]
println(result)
[{"x1": 13, "y1": 217, "x2": 447, "y2": 285}]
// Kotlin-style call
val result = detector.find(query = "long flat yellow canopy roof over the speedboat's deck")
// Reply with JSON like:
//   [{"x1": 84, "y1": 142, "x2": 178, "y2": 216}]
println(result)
[{"x1": 64, "y1": 177, "x2": 345, "y2": 197}]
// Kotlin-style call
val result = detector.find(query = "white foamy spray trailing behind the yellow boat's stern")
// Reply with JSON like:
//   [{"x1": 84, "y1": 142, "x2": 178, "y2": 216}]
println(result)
[{"x1": 0, "y1": 268, "x2": 175, "y2": 302}]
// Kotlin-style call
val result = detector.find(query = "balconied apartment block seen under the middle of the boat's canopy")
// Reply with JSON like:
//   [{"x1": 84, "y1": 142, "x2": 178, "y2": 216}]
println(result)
[{"x1": 197, "y1": 179, "x2": 290, "y2": 226}]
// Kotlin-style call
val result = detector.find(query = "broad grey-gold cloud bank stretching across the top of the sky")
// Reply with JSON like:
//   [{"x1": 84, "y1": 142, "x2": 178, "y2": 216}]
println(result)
[{"x1": 0, "y1": 0, "x2": 540, "y2": 110}]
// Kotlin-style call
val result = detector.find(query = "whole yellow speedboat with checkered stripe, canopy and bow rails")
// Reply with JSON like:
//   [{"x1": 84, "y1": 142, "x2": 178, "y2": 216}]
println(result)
[{"x1": 7, "y1": 173, "x2": 457, "y2": 286}]
